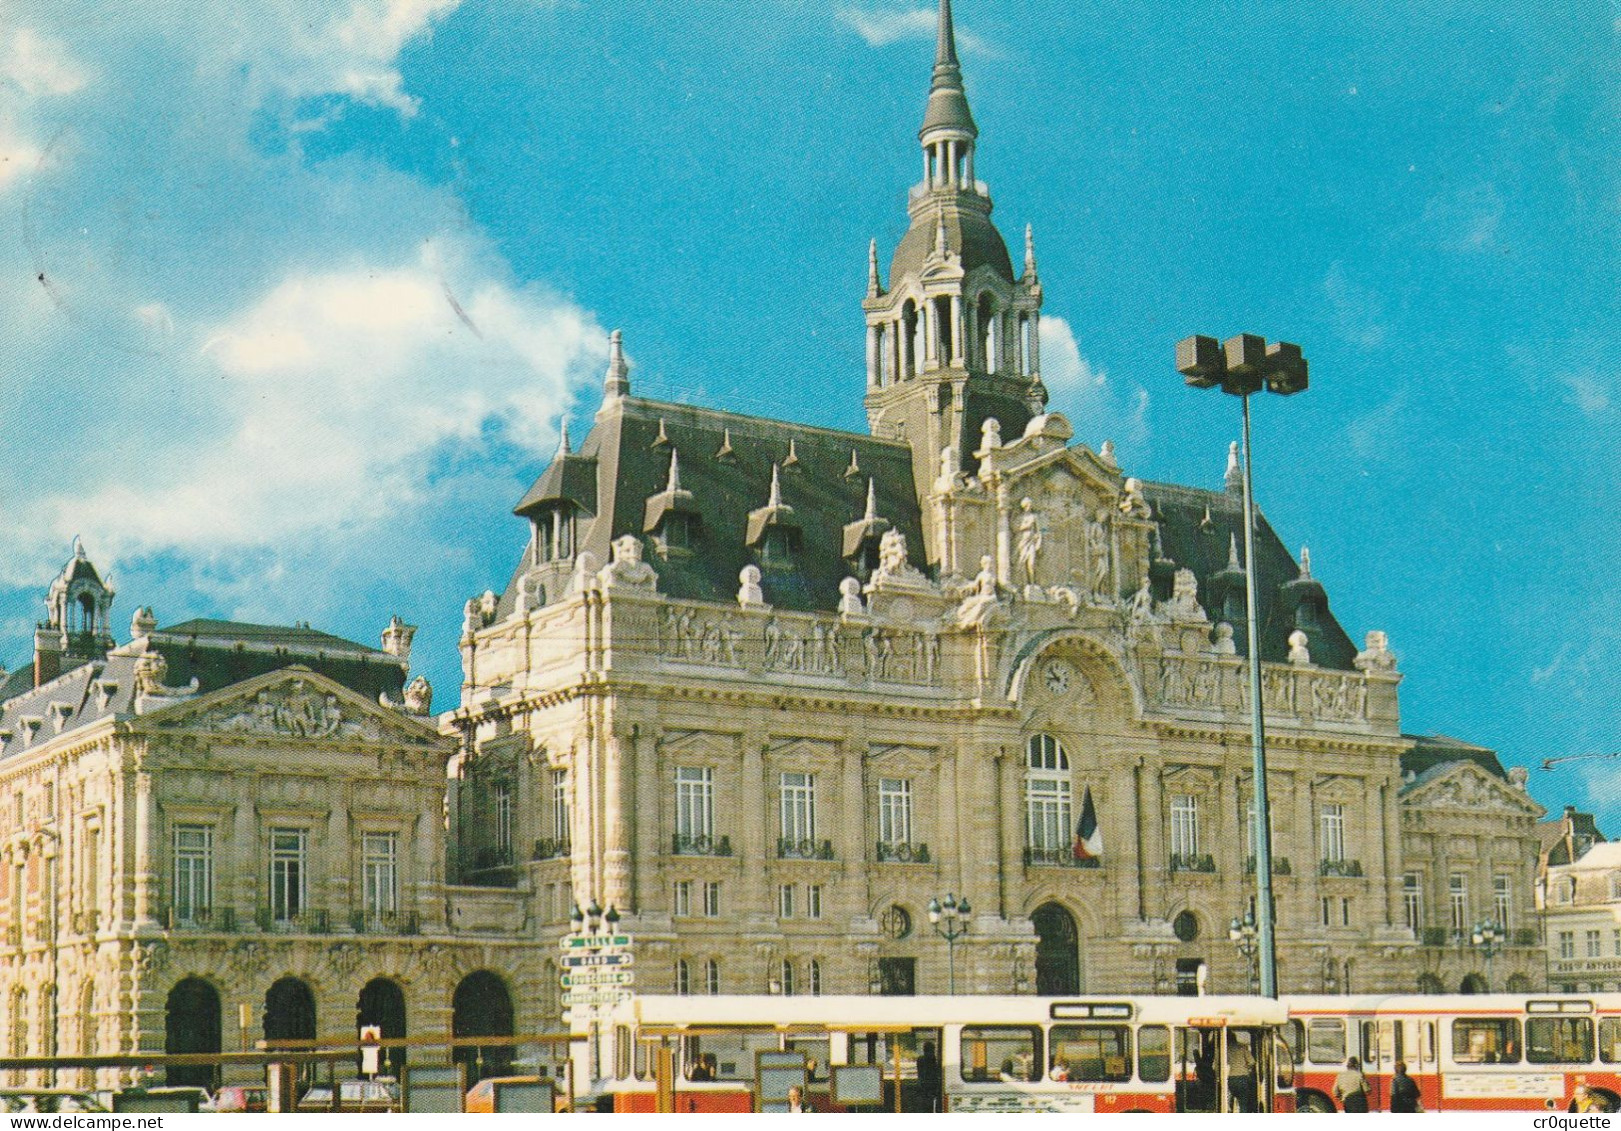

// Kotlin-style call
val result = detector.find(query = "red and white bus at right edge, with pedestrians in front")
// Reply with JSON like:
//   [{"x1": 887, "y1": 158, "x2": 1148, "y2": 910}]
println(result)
[{"x1": 1284, "y1": 993, "x2": 1621, "y2": 1112}]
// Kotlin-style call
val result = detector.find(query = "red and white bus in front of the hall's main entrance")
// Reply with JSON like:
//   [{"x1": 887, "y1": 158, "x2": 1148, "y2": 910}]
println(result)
[{"x1": 575, "y1": 995, "x2": 1295, "y2": 1112}]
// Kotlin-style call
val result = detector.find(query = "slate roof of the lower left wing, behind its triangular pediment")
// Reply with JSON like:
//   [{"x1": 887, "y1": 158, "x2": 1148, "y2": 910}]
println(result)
[{"x1": 0, "y1": 621, "x2": 405, "y2": 758}]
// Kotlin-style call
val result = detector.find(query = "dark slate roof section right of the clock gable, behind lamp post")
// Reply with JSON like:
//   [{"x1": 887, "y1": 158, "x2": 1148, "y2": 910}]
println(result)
[{"x1": 1143, "y1": 483, "x2": 1357, "y2": 671}]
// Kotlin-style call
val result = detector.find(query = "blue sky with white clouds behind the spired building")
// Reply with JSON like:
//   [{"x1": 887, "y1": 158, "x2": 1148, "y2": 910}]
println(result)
[{"x1": 0, "y1": 0, "x2": 1621, "y2": 819}]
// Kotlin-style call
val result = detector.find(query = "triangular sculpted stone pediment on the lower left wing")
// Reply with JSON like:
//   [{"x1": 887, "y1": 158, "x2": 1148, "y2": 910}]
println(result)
[{"x1": 141, "y1": 666, "x2": 439, "y2": 747}]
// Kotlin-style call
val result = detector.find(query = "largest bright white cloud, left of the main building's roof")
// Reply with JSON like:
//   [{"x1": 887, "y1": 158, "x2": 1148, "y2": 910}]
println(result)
[{"x1": 10, "y1": 241, "x2": 606, "y2": 566}]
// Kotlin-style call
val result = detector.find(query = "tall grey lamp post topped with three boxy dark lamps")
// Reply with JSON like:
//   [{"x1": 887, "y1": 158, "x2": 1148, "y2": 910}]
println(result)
[{"x1": 1177, "y1": 334, "x2": 1307, "y2": 998}]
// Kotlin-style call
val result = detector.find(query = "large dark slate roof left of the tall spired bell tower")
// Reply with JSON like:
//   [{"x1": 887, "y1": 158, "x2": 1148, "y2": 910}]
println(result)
[{"x1": 501, "y1": 397, "x2": 924, "y2": 612}]
